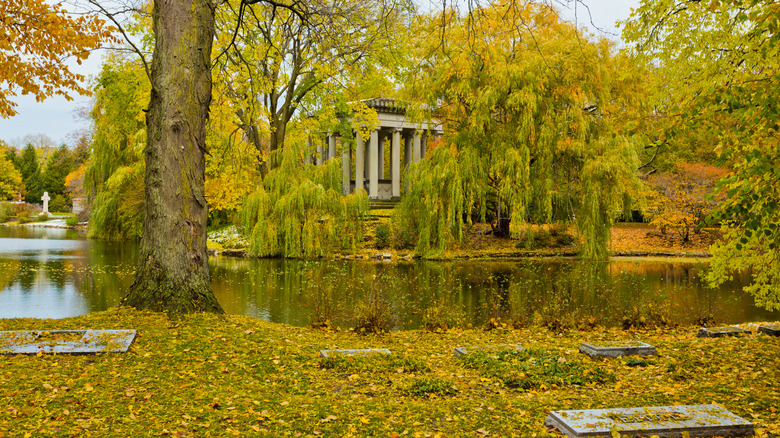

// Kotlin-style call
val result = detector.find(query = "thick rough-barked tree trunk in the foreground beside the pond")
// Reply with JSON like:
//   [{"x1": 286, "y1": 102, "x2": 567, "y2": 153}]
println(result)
[{"x1": 122, "y1": 0, "x2": 222, "y2": 317}]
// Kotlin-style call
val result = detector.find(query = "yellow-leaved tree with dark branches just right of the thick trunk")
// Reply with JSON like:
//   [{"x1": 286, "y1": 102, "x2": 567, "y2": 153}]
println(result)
[{"x1": 214, "y1": 0, "x2": 408, "y2": 174}]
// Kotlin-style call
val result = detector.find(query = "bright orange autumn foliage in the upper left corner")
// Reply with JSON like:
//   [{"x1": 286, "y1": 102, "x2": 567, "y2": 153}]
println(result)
[{"x1": 0, "y1": 0, "x2": 112, "y2": 118}]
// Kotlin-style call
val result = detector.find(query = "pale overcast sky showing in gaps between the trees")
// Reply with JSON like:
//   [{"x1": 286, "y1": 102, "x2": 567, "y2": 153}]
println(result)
[{"x1": 0, "y1": 0, "x2": 639, "y2": 145}]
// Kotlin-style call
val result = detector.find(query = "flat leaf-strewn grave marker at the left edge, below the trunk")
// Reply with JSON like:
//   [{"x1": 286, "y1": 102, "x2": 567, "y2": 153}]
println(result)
[{"x1": 0, "y1": 330, "x2": 138, "y2": 354}]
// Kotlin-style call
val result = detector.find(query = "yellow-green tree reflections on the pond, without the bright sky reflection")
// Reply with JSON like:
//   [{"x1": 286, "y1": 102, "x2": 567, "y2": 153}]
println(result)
[{"x1": 9, "y1": 248, "x2": 760, "y2": 328}]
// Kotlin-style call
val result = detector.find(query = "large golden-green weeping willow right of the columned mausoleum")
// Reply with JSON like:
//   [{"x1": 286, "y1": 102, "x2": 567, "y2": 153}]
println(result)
[{"x1": 394, "y1": 2, "x2": 640, "y2": 258}]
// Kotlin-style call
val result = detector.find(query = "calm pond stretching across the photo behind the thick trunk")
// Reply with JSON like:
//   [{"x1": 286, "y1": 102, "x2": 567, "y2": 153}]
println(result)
[{"x1": 0, "y1": 227, "x2": 780, "y2": 328}]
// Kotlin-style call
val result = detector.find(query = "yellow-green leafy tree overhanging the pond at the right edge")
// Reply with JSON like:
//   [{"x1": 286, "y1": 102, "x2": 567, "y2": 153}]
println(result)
[{"x1": 624, "y1": 0, "x2": 780, "y2": 309}]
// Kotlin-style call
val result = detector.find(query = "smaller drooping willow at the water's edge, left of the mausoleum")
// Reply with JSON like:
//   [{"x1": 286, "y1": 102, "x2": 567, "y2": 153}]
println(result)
[{"x1": 241, "y1": 142, "x2": 368, "y2": 258}]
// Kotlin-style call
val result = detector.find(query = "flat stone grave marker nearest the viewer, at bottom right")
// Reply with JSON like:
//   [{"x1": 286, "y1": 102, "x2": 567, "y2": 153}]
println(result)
[{"x1": 544, "y1": 405, "x2": 753, "y2": 438}]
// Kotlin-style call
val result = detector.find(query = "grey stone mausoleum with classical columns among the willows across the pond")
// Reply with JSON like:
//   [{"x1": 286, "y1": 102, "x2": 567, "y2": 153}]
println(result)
[{"x1": 310, "y1": 97, "x2": 442, "y2": 201}]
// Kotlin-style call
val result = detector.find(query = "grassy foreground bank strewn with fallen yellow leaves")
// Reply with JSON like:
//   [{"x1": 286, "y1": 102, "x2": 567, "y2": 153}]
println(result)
[{"x1": 0, "y1": 309, "x2": 780, "y2": 437}]
